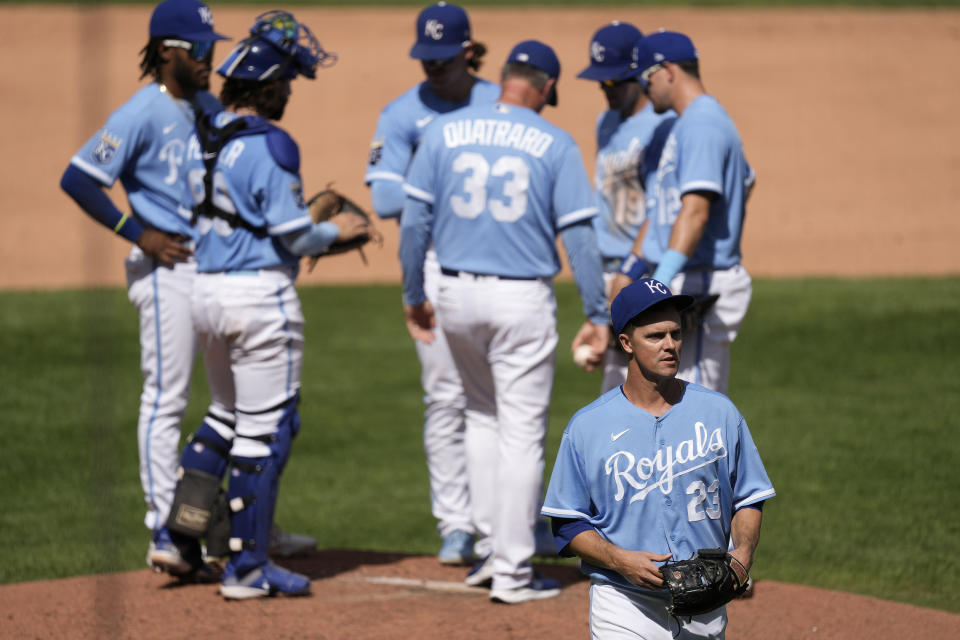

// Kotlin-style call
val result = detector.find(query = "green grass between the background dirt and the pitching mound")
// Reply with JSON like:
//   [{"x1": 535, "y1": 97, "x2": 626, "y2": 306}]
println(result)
[{"x1": 0, "y1": 278, "x2": 960, "y2": 612}]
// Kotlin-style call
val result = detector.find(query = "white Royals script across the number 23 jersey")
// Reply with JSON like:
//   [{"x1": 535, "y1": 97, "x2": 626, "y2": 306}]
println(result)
[{"x1": 604, "y1": 422, "x2": 727, "y2": 503}]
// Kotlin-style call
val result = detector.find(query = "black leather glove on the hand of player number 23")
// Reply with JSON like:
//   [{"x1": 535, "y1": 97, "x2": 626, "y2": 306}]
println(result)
[{"x1": 660, "y1": 549, "x2": 749, "y2": 617}]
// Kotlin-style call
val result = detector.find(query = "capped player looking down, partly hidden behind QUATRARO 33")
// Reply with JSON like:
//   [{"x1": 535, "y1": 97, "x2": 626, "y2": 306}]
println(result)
[{"x1": 364, "y1": 2, "x2": 500, "y2": 564}]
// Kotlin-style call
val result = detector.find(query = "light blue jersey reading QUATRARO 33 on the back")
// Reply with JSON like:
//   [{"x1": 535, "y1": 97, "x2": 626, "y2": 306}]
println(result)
[{"x1": 401, "y1": 103, "x2": 596, "y2": 278}]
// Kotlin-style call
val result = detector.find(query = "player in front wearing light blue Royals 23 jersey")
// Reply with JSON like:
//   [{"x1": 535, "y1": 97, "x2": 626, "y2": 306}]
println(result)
[{"x1": 542, "y1": 278, "x2": 775, "y2": 640}]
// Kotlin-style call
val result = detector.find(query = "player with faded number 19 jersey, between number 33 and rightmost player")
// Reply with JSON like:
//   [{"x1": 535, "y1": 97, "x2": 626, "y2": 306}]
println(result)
[{"x1": 577, "y1": 21, "x2": 676, "y2": 391}]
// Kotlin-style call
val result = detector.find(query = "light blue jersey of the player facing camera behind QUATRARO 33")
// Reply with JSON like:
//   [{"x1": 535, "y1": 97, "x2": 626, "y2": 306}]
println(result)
[{"x1": 364, "y1": 79, "x2": 500, "y2": 211}]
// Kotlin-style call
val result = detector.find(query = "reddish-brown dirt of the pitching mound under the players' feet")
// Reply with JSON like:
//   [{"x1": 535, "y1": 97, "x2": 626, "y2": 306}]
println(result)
[{"x1": 0, "y1": 550, "x2": 960, "y2": 640}]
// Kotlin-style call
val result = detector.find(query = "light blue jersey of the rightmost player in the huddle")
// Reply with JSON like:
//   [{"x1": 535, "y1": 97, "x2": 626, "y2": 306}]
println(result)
[{"x1": 643, "y1": 95, "x2": 753, "y2": 269}]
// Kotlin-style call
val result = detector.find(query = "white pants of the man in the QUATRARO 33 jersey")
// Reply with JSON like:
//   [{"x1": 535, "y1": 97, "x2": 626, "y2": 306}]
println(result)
[{"x1": 436, "y1": 275, "x2": 557, "y2": 589}]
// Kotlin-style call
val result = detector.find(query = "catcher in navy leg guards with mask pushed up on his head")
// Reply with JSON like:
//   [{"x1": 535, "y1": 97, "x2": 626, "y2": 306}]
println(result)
[{"x1": 168, "y1": 11, "x2": 368, "y2": 599}]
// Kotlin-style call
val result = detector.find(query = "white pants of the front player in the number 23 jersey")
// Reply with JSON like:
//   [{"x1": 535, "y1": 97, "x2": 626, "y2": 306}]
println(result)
[{"x1": 590, "y1": 580, "x2": 727, "y2": 640}]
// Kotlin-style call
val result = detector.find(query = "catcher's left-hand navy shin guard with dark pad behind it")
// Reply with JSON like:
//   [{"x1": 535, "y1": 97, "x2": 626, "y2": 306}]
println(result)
[{"x1": 167, "y1": 414, "x2": 232, "y2": 546}]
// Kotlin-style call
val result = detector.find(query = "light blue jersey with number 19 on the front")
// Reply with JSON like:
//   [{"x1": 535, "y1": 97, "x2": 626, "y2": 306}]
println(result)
[{"x1": 593, "y1": 102, "x2": 676, "y2": 258}]
